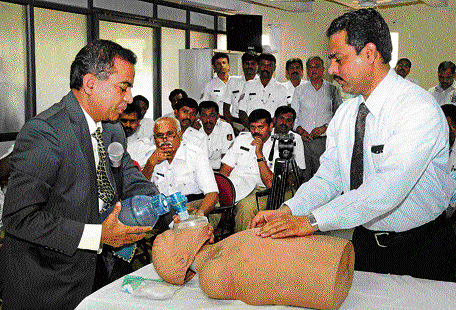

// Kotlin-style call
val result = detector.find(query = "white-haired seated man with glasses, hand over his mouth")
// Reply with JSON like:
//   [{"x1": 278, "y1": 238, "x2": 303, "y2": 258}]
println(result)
[{"x1": 139, "y1": 117, "x2": 220, "y2": 227}]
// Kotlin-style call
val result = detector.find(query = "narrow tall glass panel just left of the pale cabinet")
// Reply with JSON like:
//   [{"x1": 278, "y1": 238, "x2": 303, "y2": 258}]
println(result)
[{"x1": 162, "y1": 27, "x2": 185, "y2": 115}]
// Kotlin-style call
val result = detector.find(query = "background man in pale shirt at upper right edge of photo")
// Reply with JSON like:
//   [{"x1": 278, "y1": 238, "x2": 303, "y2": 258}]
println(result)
[{"x1": 429, "y1": 61, "x2": 456, "y2": 105}]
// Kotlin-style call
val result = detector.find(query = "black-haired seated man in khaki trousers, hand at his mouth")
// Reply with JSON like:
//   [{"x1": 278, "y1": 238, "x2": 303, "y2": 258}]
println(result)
[{"x1": 220, "y1": 109, "x2": 300, "y2": 231}]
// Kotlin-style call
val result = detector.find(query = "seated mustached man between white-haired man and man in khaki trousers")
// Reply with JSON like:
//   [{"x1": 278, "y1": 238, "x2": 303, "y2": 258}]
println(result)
[{"x1": 199, "y1": 101, "x2": 234, "y2": 170}]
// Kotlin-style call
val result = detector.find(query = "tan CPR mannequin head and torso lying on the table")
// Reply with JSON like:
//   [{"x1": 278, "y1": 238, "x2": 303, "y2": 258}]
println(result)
[{"x1": 152, "y1": 225, "x2": 354, "y2": 309}]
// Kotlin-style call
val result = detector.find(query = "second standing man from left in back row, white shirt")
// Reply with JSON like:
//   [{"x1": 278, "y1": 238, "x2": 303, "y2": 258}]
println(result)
[{"x1": 223, "y1": 51, "x2": 259, "y2": 129}]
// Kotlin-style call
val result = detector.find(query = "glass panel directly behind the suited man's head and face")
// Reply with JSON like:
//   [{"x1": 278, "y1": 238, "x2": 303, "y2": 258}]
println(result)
[{"x1": 100, "y1": 21, "x2": 154, "y2": 118}]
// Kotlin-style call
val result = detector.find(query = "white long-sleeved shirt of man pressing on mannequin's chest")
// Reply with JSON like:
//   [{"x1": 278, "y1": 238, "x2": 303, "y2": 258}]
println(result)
[{"x1": 285, "y1": 70, "x2": 456, "y2": 232}]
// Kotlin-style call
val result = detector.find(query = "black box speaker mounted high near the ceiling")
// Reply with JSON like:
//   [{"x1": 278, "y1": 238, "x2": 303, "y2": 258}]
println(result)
[{"x1": 226, "y1": 14, "x2": 263, "y2": 53}]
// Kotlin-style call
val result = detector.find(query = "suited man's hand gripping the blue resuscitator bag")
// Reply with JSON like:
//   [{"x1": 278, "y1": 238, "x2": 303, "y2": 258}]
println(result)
[{"x1": 101, "y1": 202, "x2": 152, "y2": 248}]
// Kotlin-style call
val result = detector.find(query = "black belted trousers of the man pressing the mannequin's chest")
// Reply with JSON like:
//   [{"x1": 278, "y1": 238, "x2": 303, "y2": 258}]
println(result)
[{"x1": 352, "y1": 214, "x2": 456, "y2": 282}]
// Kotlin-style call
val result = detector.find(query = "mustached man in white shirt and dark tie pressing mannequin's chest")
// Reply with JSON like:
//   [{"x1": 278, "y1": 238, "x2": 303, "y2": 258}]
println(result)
[{"x1": 250, "y1": 9, "x2": 456, "y2": 281}]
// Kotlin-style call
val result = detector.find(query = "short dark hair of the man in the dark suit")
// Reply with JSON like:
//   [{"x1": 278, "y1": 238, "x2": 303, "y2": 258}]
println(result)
[{"x1": 70, "y1": 40, "x2": 136, "y2": 90}]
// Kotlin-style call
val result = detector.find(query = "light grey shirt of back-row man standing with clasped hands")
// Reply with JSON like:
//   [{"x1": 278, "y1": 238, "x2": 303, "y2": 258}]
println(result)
[{"x1": 291, "y1": 80, "x2": 342, "y2": 134}]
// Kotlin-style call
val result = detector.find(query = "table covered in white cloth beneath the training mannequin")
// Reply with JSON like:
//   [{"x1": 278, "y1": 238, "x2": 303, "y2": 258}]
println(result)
[{"x1": 76, "y1": 264, "x2": 456, "y2": 310}]
